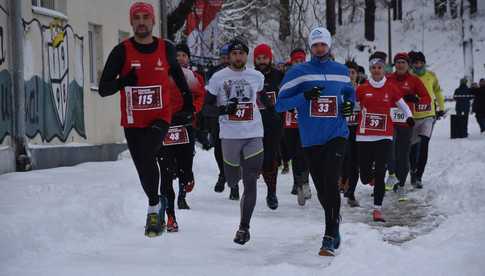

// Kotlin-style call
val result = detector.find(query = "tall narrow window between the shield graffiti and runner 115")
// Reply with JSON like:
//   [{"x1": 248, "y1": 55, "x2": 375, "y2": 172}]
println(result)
[{"x1": 88, "y1": 24, "x2": 103, "y2": 90}]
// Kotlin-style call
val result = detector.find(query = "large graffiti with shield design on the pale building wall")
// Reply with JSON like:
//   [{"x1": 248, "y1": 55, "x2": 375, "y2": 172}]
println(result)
[{"x1": 24, "y1": 19, "x2": 86, "y2": 142}]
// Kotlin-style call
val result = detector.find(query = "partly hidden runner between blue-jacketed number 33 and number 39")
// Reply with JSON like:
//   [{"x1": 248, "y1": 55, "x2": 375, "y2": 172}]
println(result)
[{"x1": 340, "y1": 60, "x2": 360, "y2": 207}]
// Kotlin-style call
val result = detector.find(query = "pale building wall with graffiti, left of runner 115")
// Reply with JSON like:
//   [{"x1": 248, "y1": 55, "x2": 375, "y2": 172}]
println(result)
[{"x1": 0, "y1": 0, "x2": 160, "y2": 172}]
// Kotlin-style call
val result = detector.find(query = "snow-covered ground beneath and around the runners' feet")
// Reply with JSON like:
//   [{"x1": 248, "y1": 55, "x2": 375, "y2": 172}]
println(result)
[{"x1": 0, "y1": 115, "x2": 485, "y2": 276}]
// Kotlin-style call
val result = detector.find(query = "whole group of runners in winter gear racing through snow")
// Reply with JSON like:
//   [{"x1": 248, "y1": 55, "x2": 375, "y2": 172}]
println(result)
[{"x1": 99, "y1": 2, "x2": 445, "y2": 256}]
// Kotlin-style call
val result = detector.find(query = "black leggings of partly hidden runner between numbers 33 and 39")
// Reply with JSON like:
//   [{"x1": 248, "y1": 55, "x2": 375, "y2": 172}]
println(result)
[{"x1": 342, "y1": 126, "x2": 359, "y2": 199}]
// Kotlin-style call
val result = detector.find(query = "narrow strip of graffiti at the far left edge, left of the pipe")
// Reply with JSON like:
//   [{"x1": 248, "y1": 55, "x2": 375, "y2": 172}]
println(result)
[{"x1": 0, "y1": 1, "x2": 13, "y2": 144}]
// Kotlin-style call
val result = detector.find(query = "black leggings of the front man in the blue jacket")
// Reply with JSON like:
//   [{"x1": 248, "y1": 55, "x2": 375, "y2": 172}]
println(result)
[{"x1": 304, "y1": 137, "x2": 346, "y2": 238}]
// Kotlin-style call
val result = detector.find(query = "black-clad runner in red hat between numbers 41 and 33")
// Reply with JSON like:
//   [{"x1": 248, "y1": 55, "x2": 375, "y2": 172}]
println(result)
[{"x1": 253, "y1": 44, "x2": 283, "y2": 210}]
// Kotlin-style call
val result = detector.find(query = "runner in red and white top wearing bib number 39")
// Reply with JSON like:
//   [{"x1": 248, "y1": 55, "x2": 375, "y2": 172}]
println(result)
[{"x1": 356, "y1": 55, "x2": 414, "y2": 222}]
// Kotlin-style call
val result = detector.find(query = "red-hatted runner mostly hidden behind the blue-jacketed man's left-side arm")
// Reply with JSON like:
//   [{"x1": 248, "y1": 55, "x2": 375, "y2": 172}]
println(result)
[{"x1": 283, "y1": 48, "x2": 312, "y2": 206}]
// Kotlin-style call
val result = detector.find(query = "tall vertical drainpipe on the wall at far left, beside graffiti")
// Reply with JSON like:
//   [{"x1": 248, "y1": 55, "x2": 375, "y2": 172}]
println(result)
[{"x1": 9, "y1": 1, "x2": 32, "y2": 171}]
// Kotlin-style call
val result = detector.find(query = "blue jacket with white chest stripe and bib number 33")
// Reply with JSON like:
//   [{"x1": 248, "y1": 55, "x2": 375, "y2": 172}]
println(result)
[{"x1": 276, "y1": 57, "x2": 355, "y2": 147}]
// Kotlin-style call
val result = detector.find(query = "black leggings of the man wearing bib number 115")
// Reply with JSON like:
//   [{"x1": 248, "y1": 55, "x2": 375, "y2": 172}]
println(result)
[{"x1": 124, "y1": 124, "x2": 168, "y2": 206}]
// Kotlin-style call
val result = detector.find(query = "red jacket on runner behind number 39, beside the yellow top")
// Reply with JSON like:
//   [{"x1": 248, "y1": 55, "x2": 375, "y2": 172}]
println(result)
[{"x1": 387, "y1": 72, "x2": 431, "y2": 127}]
